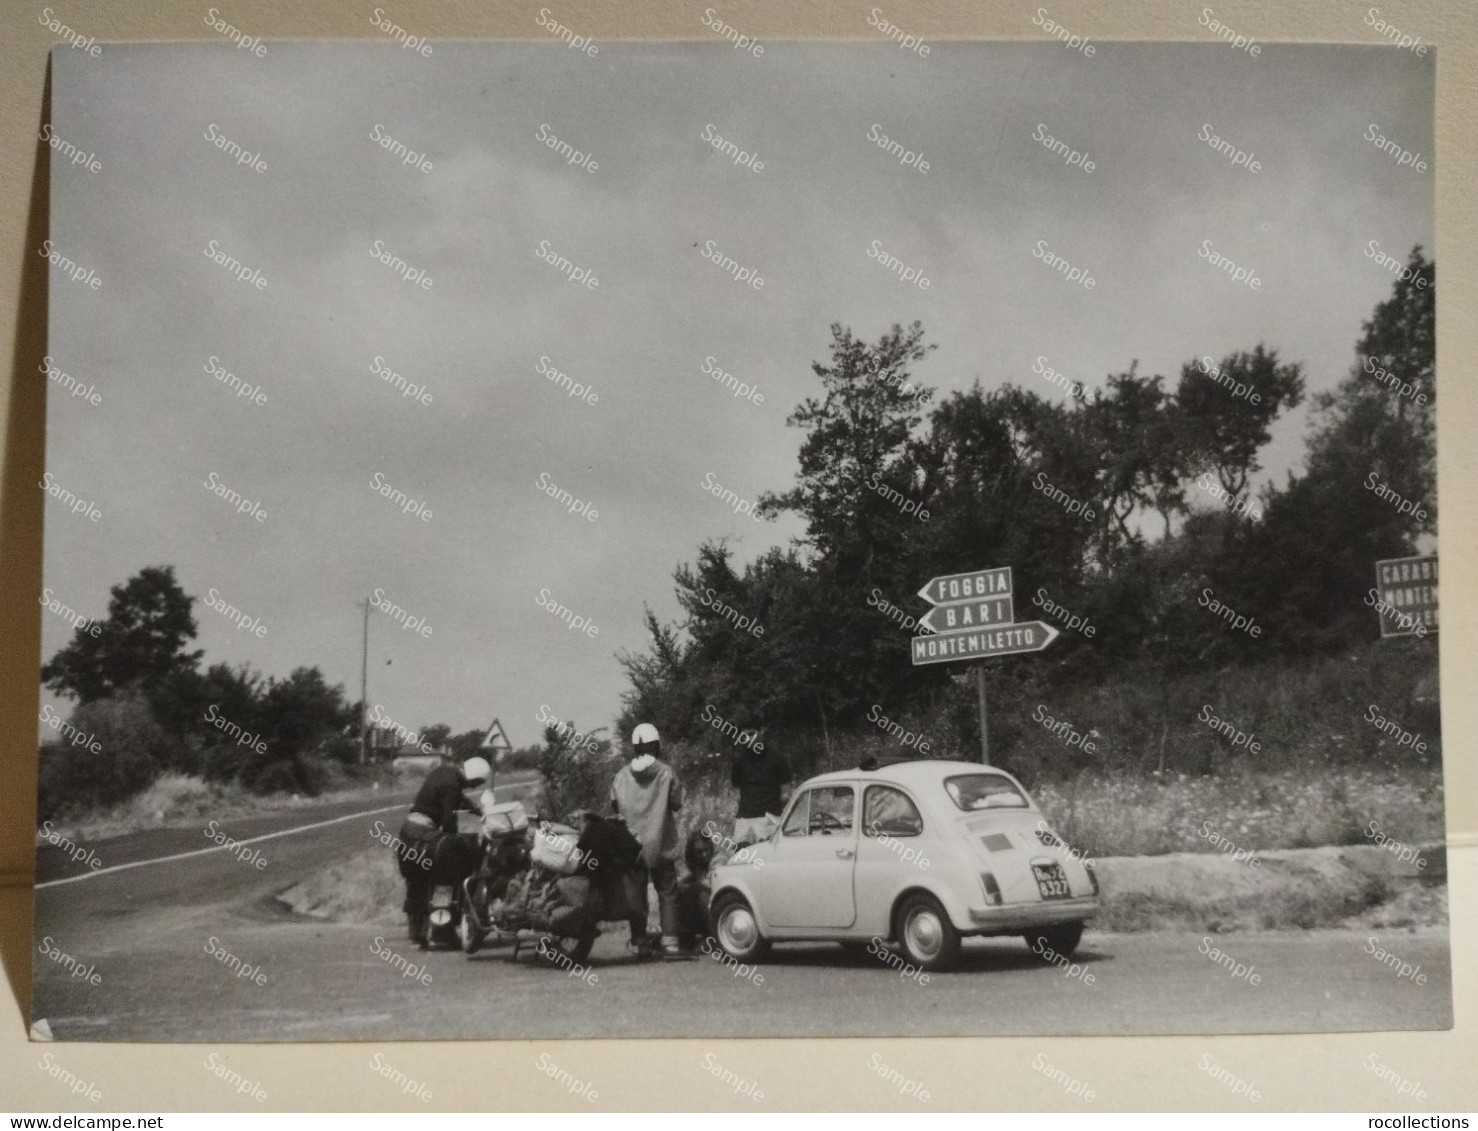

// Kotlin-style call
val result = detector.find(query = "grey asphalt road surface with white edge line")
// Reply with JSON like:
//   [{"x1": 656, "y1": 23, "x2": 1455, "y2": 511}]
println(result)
[{"x1": 31, "y1": 794, "x2": 1451, "y2": 1041}]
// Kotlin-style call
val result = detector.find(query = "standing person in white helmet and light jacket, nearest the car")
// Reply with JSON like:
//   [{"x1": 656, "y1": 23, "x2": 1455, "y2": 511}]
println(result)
[{"x1": 610, "y1": 723, "x2": 683, "y2": 955}]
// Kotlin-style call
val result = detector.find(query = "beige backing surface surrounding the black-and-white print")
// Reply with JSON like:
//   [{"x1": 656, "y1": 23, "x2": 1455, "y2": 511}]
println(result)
[{"x1": 0, "y1": 0, "x2": 1478, "y2": 1115}]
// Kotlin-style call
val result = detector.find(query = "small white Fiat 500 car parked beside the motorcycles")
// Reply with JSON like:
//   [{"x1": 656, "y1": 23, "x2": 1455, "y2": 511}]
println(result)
[{"x1": 709, "y1": 761, "x2": 1098, "y2": 970}]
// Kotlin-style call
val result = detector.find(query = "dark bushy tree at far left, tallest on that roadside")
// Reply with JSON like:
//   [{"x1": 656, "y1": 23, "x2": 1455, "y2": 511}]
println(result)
[{"x1": 41, "y1": 566, "x2": 204, "y2": 704}]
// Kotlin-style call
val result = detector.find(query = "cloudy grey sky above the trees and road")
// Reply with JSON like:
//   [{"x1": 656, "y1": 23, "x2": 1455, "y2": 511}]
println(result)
[{"x1": 41, "y1": 40, "x2": 1434, "y2": 745}]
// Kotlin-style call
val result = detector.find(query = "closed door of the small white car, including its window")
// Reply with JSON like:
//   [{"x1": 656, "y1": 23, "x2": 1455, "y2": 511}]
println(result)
[{"x1": 761, "y1": 785, "x2": 857, "y2": 928}]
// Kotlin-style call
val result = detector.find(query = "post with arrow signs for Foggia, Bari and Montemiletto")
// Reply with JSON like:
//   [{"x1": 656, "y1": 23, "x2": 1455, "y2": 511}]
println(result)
[{"x1": 910, "y1": 566, "x2": 1058, "y2": 766}]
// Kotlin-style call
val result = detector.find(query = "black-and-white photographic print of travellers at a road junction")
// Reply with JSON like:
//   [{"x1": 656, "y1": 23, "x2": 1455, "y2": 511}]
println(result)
[{"x1": 31, "y1": 26, "x2": 1453, "y2": 1052}]
